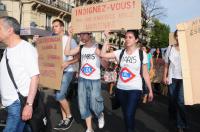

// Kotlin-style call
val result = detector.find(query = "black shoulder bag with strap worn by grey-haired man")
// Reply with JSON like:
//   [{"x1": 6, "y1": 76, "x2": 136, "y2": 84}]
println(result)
[{"x1": 5, "y1": 50, "x2": 47, "y2": 132}]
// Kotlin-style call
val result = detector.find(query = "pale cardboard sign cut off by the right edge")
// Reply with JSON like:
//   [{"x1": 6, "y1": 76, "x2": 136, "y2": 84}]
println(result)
[{"x1": 177, "y1": 18, "x2": 200, "y2": 105}]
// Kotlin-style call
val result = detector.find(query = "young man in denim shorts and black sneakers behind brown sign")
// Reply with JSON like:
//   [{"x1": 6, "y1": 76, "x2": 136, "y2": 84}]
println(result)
[{"x1": 49, "y1": 19, "x2": 78, "y2": 130}]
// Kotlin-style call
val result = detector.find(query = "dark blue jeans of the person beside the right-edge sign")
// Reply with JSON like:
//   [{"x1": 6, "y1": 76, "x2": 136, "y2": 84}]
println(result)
[{"x1": 169, "y1": 79, "x2": 188, "y2": 128}]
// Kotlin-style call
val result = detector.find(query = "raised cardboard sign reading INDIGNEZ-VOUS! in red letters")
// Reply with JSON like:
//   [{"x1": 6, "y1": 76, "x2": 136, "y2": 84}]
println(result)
[{"x1": 72, "y1": 0, "x2": 141, "y2": 33}]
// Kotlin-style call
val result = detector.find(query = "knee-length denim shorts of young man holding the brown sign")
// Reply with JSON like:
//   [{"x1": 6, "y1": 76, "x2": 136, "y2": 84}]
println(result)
[{"x1": 55, "y1": 72, "x2": 74, "y2": 101}]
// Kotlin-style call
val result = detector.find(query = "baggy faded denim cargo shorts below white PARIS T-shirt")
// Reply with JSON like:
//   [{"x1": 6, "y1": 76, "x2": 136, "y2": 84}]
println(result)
[{"x1": 78, "y1": 78, "x2": 104, "y2": 119}]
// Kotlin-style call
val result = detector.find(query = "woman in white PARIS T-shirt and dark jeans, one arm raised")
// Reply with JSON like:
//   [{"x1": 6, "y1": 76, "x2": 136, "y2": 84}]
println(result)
[{"x1": 101, "y1": 30, "x2": 153, "y2": 132}]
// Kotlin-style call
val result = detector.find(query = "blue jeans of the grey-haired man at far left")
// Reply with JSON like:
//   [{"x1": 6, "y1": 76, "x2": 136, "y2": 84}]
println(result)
[{"x1": 3, "y1": 100, "x2": 25, "y2": 132}]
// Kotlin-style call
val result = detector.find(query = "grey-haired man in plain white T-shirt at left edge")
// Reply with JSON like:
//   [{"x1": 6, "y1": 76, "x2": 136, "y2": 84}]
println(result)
[{"x1": 0, "y1": 16, "x2": 39, "y2": 132}]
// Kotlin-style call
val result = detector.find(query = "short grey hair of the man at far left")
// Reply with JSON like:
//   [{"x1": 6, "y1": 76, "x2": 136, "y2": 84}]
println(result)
[{"x1": 0, "y1": 16, "x2": 20, "y2": 35}]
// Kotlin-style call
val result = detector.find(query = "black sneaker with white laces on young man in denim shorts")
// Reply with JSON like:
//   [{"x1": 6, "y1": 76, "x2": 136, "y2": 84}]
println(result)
[{"x1": 54, "y1": 117, "x2": 74, "y2": 130}]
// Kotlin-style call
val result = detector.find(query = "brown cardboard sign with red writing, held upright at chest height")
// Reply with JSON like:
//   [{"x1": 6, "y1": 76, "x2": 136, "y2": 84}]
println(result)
[{"x1": 36, "y1": 36, "x2": 63, "y2": 90}]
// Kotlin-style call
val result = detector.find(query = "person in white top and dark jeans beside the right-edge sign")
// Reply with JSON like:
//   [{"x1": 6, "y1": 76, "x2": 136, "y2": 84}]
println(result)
[{"x1": 163, "y1": 30, "x2": 188, "y2": 132}]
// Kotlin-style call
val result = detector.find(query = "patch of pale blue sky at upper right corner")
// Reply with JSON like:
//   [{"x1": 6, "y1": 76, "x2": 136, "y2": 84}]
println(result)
[{"x1": 160, "y1": 0, "x2": 200, "y2": 31}]
